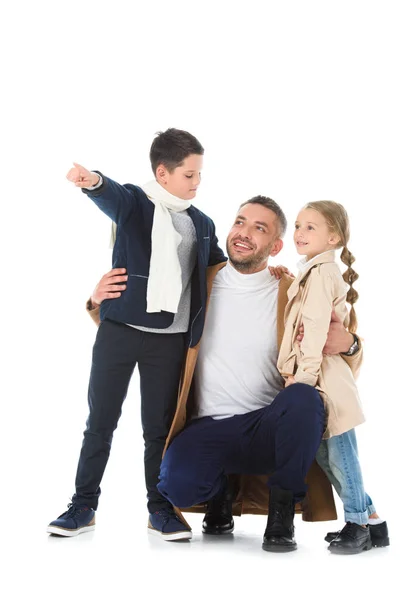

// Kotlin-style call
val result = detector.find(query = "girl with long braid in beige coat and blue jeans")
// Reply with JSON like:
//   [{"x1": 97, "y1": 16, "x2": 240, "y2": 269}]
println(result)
[{"x1": 278, "y1": 201, "x2": 389, "y2": 554}]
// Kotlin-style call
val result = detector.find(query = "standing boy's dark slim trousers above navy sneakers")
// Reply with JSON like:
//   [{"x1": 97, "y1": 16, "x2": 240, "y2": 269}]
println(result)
[{"x1": 73, "y1": 320, "x2": 185, "y2": 512}]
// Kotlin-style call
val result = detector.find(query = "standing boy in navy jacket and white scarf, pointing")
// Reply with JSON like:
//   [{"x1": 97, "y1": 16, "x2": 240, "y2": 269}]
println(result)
[{"x1": 47, "y1": 129, "x2": 225, "y2": 540}]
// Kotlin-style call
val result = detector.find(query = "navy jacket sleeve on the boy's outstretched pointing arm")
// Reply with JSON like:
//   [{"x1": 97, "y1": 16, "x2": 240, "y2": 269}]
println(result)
[{"x1": 82, "y1": 171, "x2": 141, "y2": 225}]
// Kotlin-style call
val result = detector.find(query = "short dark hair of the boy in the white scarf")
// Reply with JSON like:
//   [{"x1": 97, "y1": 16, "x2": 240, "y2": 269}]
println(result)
[{"x1": 150, "y1": 128, "x2": 204, "y2": 175}]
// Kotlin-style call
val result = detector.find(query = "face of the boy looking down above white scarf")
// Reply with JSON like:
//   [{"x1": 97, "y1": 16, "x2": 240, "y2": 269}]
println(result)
[{"x1": 156, "y1": 154, "x2": 203, "y2": 200}]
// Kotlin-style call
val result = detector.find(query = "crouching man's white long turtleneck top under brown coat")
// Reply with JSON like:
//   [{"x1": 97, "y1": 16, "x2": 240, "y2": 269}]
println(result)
[{"x1": 195, "y1": 263, "x2": 283, "y2": 419}]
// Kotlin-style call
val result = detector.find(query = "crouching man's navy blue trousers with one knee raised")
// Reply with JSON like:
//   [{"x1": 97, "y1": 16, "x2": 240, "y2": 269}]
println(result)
[{"x1": 157, "y1": 383, "x2": 325, "y2": 508}]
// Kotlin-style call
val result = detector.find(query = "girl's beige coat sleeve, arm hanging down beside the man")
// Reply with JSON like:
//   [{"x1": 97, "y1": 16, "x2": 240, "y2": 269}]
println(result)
[{"x1": 294, "y1": 268, "x2": 335, "y2": 386}]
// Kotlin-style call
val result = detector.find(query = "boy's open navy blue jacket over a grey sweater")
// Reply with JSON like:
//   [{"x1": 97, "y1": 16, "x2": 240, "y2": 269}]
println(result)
[{"x1": 82, "y1": 171, "x2": 226, "y2": 346}]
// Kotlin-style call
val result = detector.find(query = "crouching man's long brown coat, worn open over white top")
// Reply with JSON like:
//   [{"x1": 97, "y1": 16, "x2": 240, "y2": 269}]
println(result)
[{"x1": 87, "y1": 263, "x2": 360, "y2": 521}]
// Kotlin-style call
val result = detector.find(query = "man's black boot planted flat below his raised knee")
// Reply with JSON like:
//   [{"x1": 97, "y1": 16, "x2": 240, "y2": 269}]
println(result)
[{"x1": 262, "y1": 488, "x2": 297, "y2": 552}]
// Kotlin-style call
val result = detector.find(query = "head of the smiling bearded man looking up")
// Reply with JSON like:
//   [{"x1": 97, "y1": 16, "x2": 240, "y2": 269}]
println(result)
[{"x1": 226, "y1": 204, "x2": 283, "y2": 273}]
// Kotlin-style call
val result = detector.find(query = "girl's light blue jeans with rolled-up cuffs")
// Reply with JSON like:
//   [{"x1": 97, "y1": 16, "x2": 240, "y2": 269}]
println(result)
[{"x1": 316, "y1": 429, "x2": 375, "y2": 525}]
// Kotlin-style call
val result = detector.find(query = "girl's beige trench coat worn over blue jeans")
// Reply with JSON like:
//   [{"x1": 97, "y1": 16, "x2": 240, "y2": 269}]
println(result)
[{"x1": 278, "y1": 251, "x2": 364, "y2": 439}]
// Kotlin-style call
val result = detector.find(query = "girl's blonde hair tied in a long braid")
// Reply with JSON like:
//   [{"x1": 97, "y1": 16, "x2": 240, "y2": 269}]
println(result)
[{"x1": 304, "y1": 200, "x2": 358, "y2": 333}]
